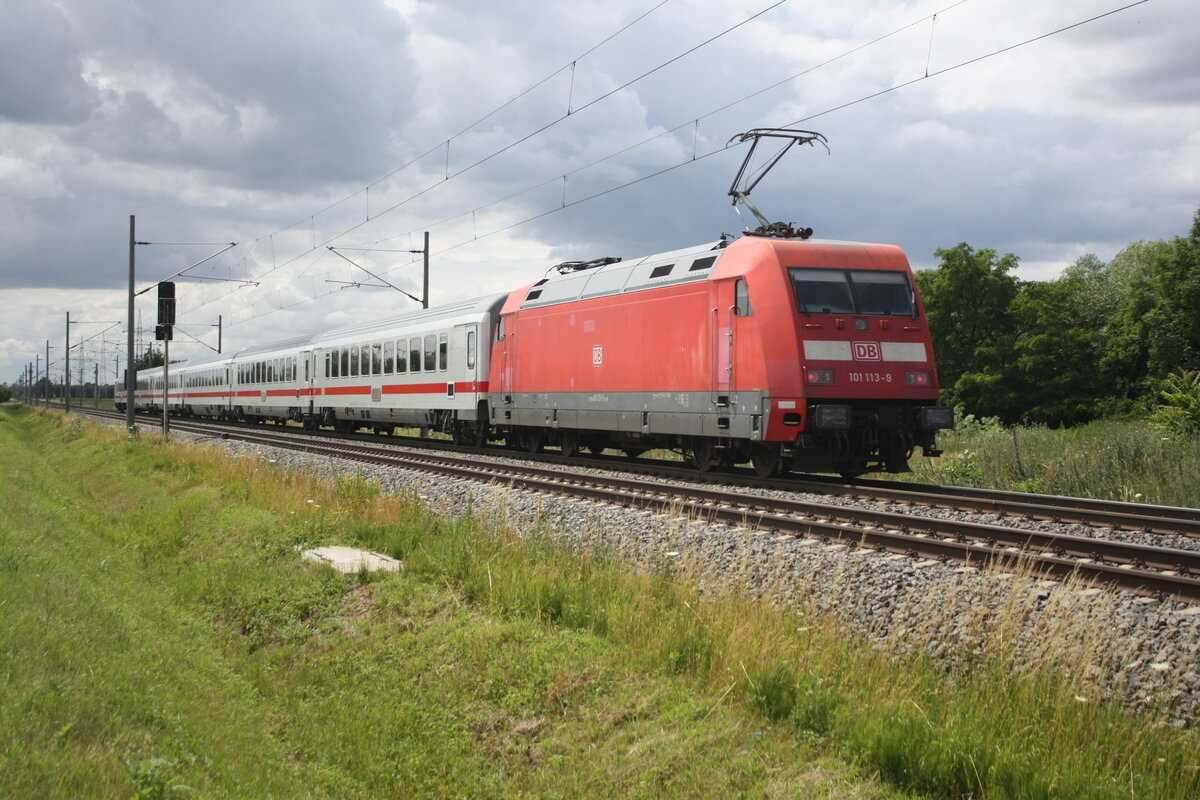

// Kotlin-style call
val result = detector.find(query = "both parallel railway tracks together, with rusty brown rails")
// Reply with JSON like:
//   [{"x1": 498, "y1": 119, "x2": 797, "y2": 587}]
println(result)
[{"x1": 72, "y1": 407, "x2": 1200, "y2": 603}]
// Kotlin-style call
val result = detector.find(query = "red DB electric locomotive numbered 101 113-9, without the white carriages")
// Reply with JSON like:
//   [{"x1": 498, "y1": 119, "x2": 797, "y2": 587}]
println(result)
[{"x1": 490, "y1": 231, "x2": 953, "y2": 475}]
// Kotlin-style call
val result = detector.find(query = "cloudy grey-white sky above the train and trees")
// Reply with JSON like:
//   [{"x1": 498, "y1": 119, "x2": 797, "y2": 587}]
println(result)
[{"x1": 0, "y1": 0, "x2": 1200, "y2": 383}]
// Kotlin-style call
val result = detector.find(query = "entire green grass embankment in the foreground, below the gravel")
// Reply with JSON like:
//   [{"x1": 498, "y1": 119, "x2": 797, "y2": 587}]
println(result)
[{"x1": 0, "y1": 405, "x2": 1200, "y2": 798}]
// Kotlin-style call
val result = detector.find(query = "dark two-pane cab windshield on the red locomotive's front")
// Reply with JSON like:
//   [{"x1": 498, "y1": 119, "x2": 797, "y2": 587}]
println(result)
[{"x1": 787, "y1": 266, "x2": 917, "y2": 318}]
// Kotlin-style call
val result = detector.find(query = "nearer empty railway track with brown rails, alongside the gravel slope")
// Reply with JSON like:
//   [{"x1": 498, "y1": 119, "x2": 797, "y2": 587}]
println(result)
[{"x1": 126, "y1": 410, "x2": 1200, "y2": 603}]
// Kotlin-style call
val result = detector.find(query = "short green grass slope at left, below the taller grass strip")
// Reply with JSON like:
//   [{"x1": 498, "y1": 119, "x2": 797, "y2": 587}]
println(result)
[{"x1": 0, "y1": 405, "x2": 899, "y2": 798}]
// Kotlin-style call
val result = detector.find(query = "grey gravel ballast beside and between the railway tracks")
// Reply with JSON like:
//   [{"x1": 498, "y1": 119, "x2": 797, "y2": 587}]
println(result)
[{"x1": 129, "y1": 422, "x2": 1200, "y2": 727}]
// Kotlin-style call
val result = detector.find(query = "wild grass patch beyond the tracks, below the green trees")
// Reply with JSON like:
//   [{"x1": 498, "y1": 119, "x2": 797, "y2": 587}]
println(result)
[{"x1": 910, "y1": 416, "x2": 1200, "y2": 509}]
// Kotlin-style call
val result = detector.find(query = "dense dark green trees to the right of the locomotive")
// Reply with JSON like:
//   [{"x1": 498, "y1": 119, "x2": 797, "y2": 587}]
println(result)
[{"x1": 916, "y1": 211, "x2": 1200, "y2": 427}]
